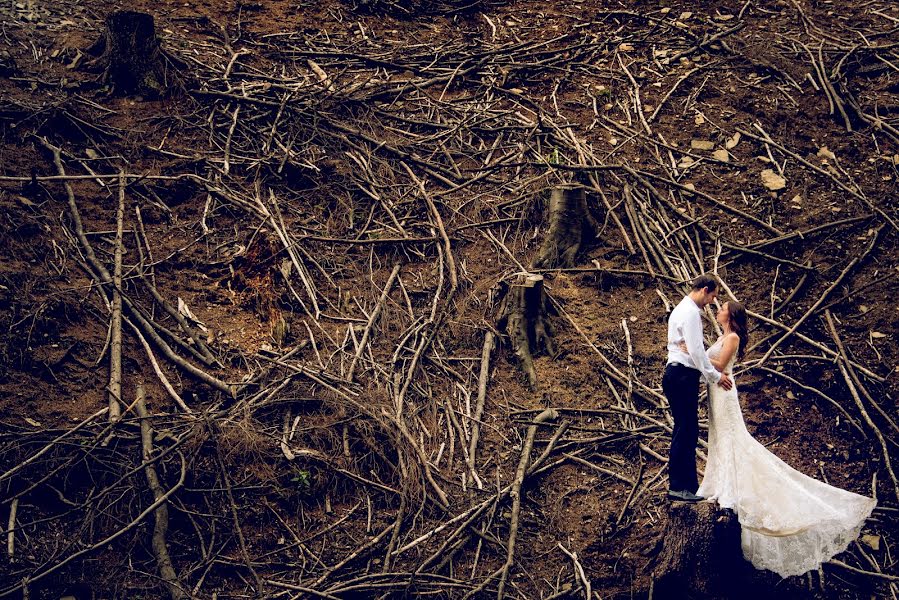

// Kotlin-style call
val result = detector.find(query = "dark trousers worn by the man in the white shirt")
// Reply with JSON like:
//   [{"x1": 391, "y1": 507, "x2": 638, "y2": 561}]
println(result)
[{"x1": 662, "y1": 365, "x2": 701, "y2": 492}]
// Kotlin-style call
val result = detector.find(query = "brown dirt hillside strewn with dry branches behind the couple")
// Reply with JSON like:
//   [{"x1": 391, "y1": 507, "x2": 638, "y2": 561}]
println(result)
[{"x1": 0, "y1": 0, "x2": 899, "y2": 600}]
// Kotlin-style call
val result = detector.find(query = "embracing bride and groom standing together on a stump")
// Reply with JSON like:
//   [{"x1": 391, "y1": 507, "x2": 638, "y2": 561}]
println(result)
[{"x1": 662, "y1": 275, "x2": 877, "y2": 577}]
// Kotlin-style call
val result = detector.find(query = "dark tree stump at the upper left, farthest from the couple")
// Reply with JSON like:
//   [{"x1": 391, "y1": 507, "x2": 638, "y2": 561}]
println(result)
[{"x1": 86, "y1": 10, "x2": 172, "y2": 98}]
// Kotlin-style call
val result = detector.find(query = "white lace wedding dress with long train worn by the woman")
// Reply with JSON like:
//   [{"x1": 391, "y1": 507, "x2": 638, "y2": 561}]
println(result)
[{"x1": 697, "y1": 339, "x2": 877, "y2": 577}]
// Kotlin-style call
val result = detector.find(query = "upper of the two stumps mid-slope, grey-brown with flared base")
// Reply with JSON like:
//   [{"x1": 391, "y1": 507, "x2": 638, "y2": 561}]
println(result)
[{"x1": 532, "y1": 187, "x2": 595, "y2": 269}]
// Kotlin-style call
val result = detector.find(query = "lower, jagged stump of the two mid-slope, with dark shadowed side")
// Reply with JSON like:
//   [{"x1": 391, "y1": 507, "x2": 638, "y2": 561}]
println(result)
[{"x1": 500, "y1": 273, "x2": 555, "y2": 388}]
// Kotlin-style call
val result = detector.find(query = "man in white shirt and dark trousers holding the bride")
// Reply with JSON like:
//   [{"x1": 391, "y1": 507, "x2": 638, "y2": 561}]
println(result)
[{"x1": 662, "y1": 275, "x2": 733, "y2": 502}]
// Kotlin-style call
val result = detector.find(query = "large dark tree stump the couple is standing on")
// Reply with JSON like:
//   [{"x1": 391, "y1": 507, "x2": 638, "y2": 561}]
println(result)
[{"x1": 653, "y1": 502, "x2": 745, "y2": 599}]
